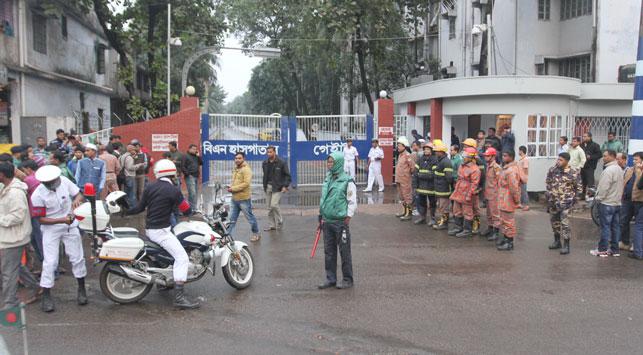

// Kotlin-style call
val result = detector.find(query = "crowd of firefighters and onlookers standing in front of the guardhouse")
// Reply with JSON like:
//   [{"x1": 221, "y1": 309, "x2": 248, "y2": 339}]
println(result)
[{"x1": 394, "y1": 126, "x2": 643, "y2": 260}]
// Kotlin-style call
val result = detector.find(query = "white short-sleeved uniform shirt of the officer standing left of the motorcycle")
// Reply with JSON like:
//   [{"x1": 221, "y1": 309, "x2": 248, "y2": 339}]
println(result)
[{"x1": 31, "y1": 176, "x2": 80, "y2": 230}]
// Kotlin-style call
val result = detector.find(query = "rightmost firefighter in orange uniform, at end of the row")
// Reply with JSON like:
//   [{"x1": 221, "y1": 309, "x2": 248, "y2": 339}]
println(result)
[{"x1": 498, "y1": 150, "x2": 520, "y2": 250}]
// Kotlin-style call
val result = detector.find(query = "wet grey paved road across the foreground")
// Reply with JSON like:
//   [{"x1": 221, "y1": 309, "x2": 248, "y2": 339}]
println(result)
[{"x1": 1, "y1": 205, "x2": 643, "y2": 354}]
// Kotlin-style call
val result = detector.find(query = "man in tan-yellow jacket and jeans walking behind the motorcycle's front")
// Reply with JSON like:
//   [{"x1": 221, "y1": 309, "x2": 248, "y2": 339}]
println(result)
[{"x1": 228, "y1": 152, "x2": 261, "y2": 242}]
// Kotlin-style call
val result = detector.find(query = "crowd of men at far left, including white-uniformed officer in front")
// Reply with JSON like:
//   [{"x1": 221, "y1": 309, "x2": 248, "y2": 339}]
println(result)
[{"x1": 0, "y1": 129, "x2": 202, "y2": 311}]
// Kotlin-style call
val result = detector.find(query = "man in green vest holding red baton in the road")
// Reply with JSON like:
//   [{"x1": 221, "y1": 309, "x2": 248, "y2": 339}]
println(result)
[{"x1": 319, "y1": 152, "x2": 357, "y2": 290}]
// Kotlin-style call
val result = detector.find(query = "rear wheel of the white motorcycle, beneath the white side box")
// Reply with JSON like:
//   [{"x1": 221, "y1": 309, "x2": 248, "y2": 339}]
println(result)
[{"x1": 100, "y1": 263, "x2": 153, "y2": 304}]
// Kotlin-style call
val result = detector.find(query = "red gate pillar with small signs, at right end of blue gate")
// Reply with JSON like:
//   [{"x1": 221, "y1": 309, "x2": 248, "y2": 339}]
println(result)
[{"x1": 373, "y1": 99, "x2": 394, "y2": 185}]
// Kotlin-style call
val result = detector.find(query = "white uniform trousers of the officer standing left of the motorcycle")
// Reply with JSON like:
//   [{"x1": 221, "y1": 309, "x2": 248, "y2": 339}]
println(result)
[{"x1": 40, "y1": 225, "x2": 87, "y2": 288}]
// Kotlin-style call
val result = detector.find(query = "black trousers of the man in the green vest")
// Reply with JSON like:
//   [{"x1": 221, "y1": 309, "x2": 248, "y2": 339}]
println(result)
[{"x1": 323, "y1": 221, "x2": 353, "y2": 283}]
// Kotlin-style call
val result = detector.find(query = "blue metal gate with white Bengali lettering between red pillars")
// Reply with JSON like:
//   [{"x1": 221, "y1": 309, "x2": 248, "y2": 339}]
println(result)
[{"x1": 201, "y1": 114, "x2": 374, "y2": 186}]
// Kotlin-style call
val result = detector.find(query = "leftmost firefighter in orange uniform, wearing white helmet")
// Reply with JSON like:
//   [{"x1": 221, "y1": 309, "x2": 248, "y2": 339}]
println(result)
[{"x1": 395, "y1": 136, "x2": 415, "y2": 221}]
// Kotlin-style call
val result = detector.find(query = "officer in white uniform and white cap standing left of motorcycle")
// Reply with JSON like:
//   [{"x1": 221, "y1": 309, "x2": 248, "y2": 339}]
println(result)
[{"x1": 31, "y1": 165, "x2": 87, "y2": 312}]
